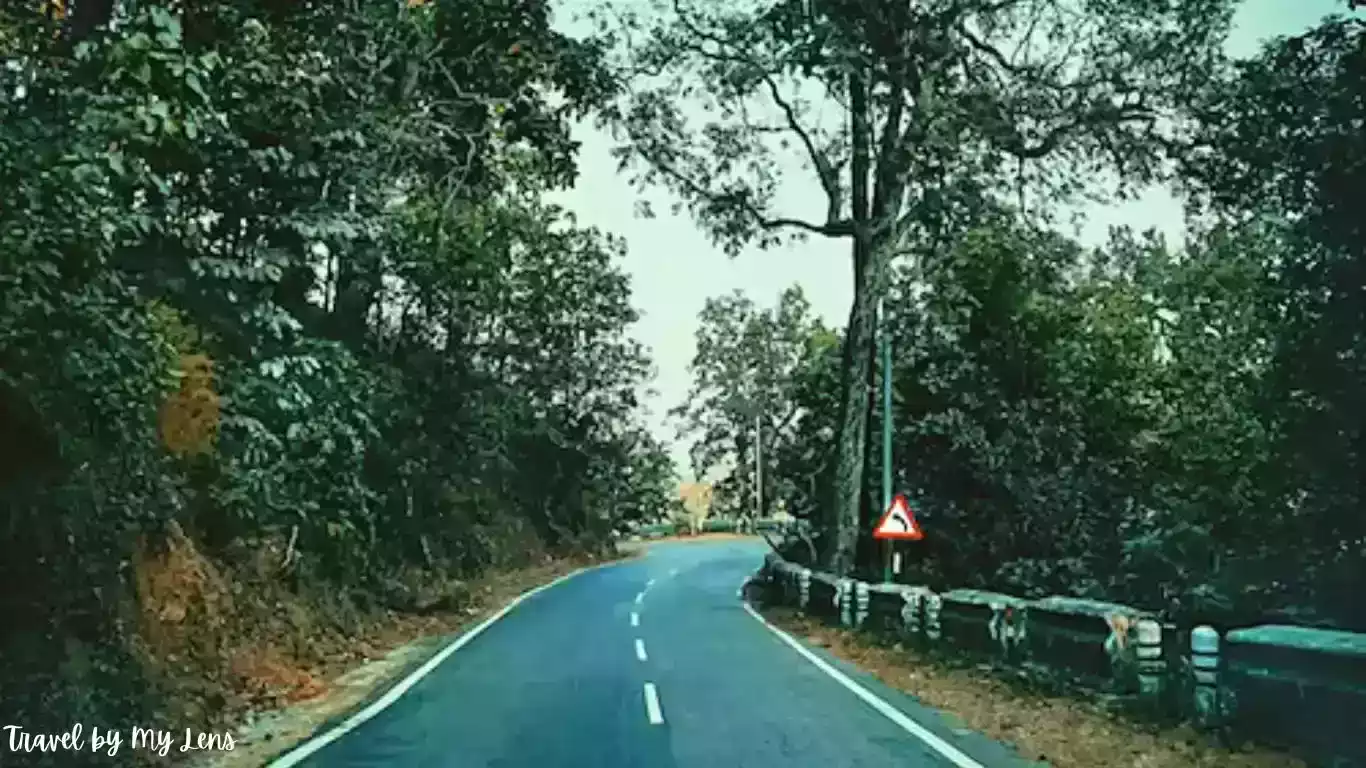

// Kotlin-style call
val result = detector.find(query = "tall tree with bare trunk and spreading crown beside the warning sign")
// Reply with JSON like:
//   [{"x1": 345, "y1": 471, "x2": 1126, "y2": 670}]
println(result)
[{"x1": 600, "y1": 0, "x2": 1233, "y2": 573}]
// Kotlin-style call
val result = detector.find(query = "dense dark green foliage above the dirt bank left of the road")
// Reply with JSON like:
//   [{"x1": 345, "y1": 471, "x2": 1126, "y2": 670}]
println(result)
[{"x1": 0, "y1": 0, "x2": 671, "y2": 731}]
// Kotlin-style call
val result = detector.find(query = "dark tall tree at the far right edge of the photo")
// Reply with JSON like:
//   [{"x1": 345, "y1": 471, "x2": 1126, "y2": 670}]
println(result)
[{"x1": 1190, "y1": 8, "x2": 1366, "y2": 620}]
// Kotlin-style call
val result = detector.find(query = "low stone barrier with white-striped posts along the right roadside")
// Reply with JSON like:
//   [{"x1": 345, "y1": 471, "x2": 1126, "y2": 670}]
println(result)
[{"x1": 754, "y1": 552, "x2": 1366, "y2": 768}]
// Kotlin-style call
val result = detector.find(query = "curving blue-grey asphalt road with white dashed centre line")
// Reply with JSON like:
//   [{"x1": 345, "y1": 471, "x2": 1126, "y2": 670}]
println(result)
[{"x1": 277, "y1": 540, "x2": 1020, "y2": 768}]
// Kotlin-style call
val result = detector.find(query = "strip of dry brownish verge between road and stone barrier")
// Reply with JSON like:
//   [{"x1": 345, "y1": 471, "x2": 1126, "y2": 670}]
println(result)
[{"x1": 762, "y1": 608, "x2": 1305, "y2": 768}]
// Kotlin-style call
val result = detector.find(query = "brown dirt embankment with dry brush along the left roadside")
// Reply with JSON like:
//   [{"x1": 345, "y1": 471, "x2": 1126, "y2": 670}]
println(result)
[{"x1": 133, "y1": 519, "x2": 625, "y2": 768}]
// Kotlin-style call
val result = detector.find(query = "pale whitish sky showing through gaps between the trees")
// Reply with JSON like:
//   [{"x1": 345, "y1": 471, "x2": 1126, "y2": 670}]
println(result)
[{"x1": 550, "y1": 0, "x2": 1343, "y2": 478}]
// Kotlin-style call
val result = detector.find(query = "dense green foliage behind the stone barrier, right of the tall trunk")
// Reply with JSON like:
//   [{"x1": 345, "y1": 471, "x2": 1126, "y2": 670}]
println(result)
[{"x1": 674, "y1": 10, "x2": 1366, "y2": 630}]
